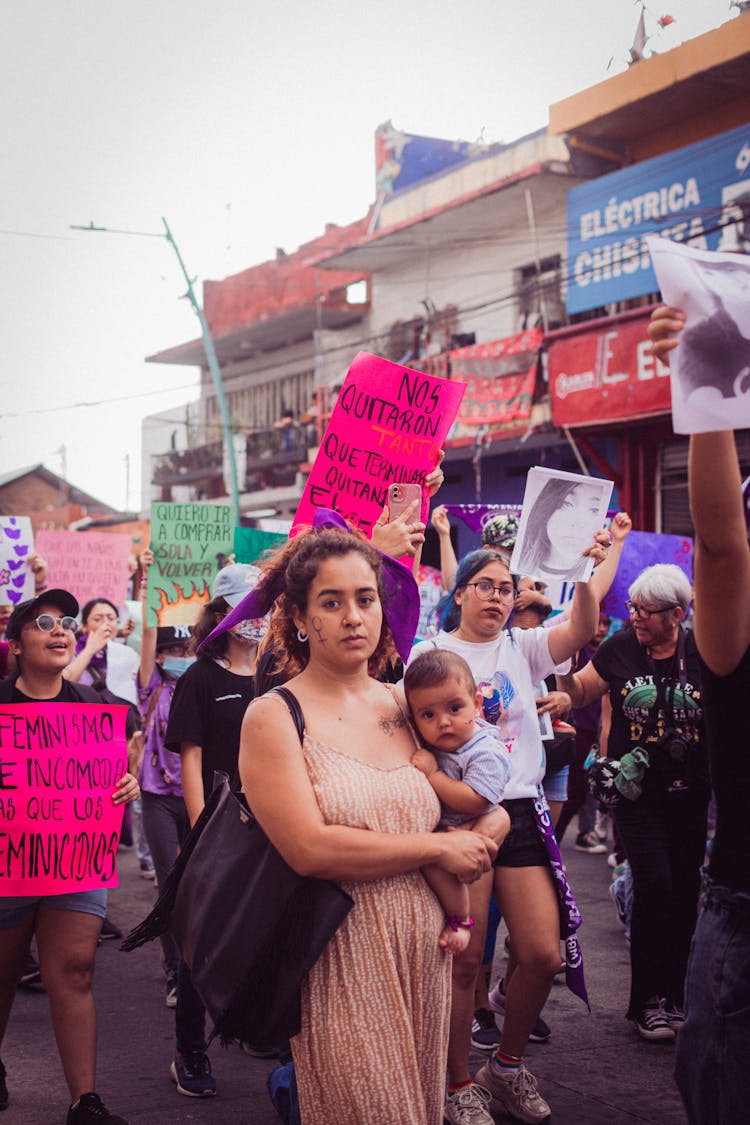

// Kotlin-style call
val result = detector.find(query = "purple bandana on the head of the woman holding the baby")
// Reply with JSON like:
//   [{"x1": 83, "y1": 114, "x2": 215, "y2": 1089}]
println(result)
[{"x1": 198, "y1": 507, "x2": 419, "y2": 664}]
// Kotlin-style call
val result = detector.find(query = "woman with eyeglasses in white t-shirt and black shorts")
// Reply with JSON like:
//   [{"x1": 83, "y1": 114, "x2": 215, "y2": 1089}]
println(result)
[{"x1": 409, "y1": 546, "x2": 604, "y2": 1125}]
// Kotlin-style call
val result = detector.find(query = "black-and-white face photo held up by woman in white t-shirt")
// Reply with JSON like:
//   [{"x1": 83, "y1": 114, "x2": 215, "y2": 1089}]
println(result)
[{"x1": 510, "y1": 468, "x2": 612, "y2": 582}]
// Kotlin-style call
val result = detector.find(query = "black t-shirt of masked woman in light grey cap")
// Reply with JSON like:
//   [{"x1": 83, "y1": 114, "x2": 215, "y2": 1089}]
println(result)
[{"x1": 164, "y1": 657, "x2": 255, "y2": 798}]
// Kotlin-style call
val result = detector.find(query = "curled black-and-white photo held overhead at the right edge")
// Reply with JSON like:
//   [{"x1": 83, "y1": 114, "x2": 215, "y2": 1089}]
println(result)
[{"x1": 649, "y1": 237, "x2": 750, "y2": 433}]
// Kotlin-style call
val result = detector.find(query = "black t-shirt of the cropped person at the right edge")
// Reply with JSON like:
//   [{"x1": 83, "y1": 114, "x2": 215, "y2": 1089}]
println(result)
[{"x1": 702, "y1": 648, "x2": 750, "y2": 893}]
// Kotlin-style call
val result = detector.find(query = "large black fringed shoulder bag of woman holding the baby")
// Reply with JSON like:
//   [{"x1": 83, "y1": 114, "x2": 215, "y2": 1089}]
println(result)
[{"x1": 123, "y1": 687, "x2": 354, "y2": 1044}]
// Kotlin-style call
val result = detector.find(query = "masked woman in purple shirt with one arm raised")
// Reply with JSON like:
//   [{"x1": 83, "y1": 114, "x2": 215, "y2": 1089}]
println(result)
[{"x1": 137, "y1": 550, "x2": 195, "y2": 1008}]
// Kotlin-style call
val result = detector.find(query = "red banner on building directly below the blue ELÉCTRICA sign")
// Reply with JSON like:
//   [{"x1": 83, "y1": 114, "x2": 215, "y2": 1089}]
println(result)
[{"x1": 546, "y1": 312, "x2": 671, "y2": 426}]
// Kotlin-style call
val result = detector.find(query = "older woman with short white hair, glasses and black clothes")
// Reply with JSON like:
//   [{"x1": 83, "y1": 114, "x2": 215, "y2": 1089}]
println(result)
[{"x1": 563, "y1": 565, "x2": 710, "y2": 1041}]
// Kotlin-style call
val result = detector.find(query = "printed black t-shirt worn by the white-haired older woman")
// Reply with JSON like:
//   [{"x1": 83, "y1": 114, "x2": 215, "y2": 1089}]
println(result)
[{"x1": 591, "y1": 629, "x2": 708, "y2": 790}]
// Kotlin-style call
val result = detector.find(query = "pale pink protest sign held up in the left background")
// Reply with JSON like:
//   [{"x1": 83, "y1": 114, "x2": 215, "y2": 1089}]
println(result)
[{"x1": 36, "y1": 531, "x2": 130, "y2": 605}]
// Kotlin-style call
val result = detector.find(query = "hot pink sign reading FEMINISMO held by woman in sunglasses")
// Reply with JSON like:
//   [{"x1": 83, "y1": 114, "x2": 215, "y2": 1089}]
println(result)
[{"x1": 0, "y1": 703, "x2": 127, "y2": 897}]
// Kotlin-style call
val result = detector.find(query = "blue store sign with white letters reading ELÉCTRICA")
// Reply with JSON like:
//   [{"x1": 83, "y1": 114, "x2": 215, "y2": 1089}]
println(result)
[{"x1": 567, "y1": 125, "x2": 750, "y2": 313}]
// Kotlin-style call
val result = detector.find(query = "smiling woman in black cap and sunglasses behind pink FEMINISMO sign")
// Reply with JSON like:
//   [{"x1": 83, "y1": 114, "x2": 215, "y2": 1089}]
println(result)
[{"x1": 0, "y1": 590, "x2": 139, "y2": 1125}]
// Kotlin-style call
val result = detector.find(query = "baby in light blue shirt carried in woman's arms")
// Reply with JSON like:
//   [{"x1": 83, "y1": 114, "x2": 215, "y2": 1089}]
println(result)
[{"x1": 404, "y1": 648, "x2": 510, "y2": 953}]
